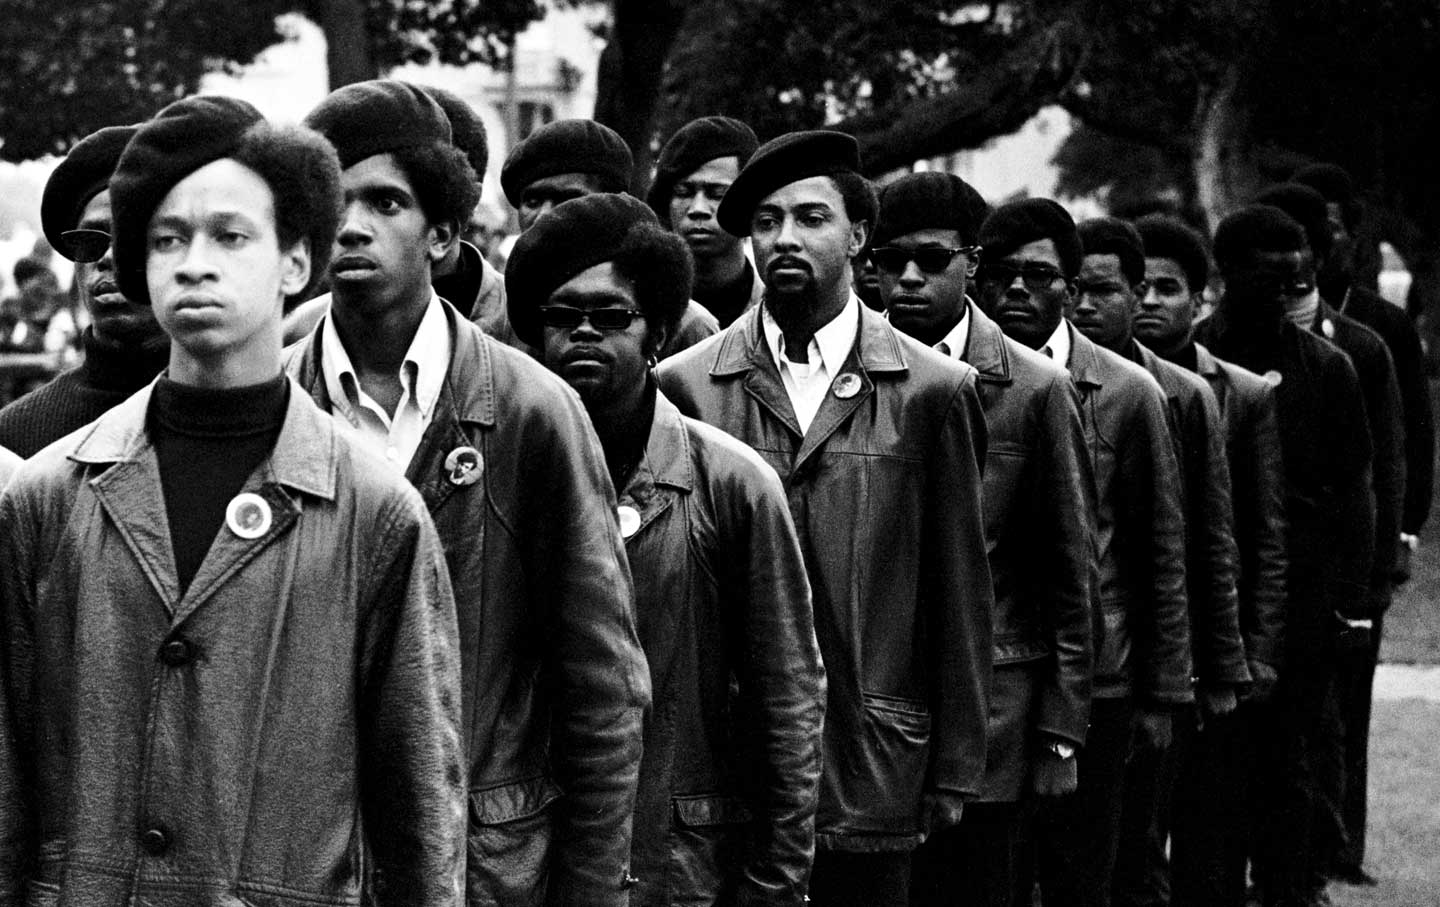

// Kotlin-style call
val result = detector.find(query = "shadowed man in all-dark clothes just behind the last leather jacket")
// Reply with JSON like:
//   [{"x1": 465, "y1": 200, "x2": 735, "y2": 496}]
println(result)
[{"x1": 1195, "y1": 204, "x2": 1375, "y2": 904}]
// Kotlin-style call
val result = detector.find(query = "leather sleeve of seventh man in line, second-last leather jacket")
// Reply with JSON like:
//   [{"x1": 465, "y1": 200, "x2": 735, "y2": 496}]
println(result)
[{"x1": 1184, "y1": 383, "x2": 1250, "y2": 687}]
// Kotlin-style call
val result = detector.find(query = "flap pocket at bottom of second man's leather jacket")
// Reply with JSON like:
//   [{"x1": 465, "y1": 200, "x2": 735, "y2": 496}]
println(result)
[{"x1": 465, "y1": 776, "x2": 560, "y2": 907}]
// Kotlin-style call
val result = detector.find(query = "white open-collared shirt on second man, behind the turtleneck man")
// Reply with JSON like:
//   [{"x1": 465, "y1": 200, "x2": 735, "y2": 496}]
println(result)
[{"x1": 320, "y1": 292, "x2": 451, "y2": 474}]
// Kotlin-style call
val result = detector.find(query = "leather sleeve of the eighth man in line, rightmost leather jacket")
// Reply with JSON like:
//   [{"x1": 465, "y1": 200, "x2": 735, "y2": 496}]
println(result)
[{"x1": 1230, "y1": 383, "x2": 1290, "y2": 668}]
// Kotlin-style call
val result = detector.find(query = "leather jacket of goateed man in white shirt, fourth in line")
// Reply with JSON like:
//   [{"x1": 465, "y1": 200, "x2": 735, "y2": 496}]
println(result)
[{"x1": 660, "y1": 302, "x2": 994, "y2": 851}]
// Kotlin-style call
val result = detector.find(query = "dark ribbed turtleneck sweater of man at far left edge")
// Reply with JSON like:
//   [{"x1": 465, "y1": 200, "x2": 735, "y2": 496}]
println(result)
[{"x1": 0, "y1": 328, "x2": 170, "y2": 456}]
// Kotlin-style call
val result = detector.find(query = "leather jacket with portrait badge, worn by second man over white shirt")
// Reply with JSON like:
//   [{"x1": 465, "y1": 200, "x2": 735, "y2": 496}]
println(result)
[{"x1": 289, "y1": 302, "x2": 649, "y2": 907}]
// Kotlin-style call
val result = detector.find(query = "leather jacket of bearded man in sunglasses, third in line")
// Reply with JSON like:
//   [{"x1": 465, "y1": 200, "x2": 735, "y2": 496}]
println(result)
[{"x1": 621, "y1": 394, "x2": 825, "y2": 907}]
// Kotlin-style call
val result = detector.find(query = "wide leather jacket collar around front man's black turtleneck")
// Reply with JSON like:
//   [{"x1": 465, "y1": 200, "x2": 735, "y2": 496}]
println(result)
[{"x1": 69, "y1": 379, "x2": 337, "y2": 501}]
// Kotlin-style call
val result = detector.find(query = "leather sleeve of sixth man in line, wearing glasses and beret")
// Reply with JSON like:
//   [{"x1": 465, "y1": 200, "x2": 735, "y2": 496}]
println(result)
[{"x1": 1120, "y1": 386, "x2": 1195, "y2": 705}]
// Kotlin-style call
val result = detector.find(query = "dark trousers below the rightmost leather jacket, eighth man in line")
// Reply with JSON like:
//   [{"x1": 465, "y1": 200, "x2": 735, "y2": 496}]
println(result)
[{"x1": 1169, "y1": 703, "x2": 1257, "y2": 907}]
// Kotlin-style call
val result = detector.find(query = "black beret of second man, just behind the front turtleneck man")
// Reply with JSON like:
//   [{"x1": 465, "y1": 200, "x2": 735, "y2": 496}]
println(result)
[{"x1": 305, "y1": 79, "x2": 454, "y2": 168}]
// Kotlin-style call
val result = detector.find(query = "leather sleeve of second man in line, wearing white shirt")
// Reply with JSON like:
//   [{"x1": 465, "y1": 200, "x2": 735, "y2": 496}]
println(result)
[{"x1": 521, "y1": 389, "x2": 649, "y2": 907}]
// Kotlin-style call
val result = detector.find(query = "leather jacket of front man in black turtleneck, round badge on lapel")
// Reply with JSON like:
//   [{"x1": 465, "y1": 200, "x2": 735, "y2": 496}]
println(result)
[{"x1": 0, "y1": 387, "x2": 465, "y2": 907}]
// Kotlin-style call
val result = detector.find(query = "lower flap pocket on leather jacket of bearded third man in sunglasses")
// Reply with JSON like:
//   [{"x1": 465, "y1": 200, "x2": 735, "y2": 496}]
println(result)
[{"x1": 665, "y1": 796, "x2": 750, "y2": 907}]
